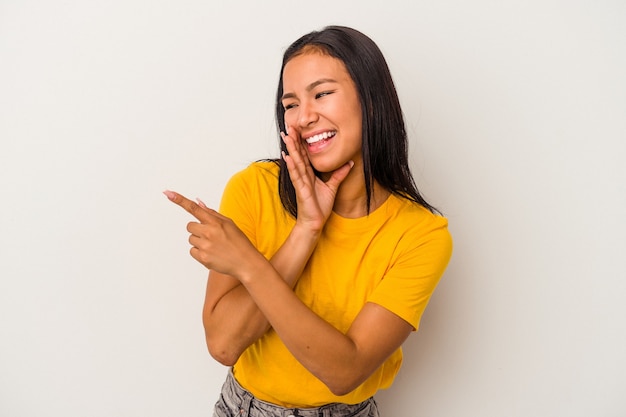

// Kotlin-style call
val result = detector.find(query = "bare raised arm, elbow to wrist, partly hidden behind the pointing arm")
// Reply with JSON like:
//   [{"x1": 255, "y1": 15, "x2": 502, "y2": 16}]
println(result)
[{"x1": 203, "y1": 226, "x2": 318, "y2": 365}]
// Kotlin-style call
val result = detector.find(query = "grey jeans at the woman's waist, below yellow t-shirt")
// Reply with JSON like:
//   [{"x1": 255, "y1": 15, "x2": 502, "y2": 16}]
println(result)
[{"x1": 213, "y1": 371, "x2": 379, "y2": 417}]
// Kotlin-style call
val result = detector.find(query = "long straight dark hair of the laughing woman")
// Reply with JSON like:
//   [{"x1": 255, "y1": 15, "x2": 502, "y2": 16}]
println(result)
[{"x1": 276, "y1": 26, "x2": 438, "y2": 217}]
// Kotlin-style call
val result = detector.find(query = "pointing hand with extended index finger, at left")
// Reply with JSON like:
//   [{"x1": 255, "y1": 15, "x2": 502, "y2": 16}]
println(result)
[{"x1": 163, "y1": 191, "x2": 265, "y2": 278}]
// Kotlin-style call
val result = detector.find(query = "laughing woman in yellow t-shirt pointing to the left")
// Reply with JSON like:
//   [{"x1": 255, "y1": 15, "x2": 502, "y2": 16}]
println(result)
[{"x1": 165, "y1": 26, "x2": 452, "y2": 417}]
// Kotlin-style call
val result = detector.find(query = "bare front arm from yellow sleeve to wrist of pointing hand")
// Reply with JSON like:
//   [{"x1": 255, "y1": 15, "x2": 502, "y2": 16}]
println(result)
[{"x1": 205, "y1": 240, "x2": 413, "y2": 395}]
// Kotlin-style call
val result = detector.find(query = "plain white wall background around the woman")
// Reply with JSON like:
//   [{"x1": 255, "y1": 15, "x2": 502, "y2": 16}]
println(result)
[{"x1": 0, "y1": 0, "x2": 626, "y2": 417}]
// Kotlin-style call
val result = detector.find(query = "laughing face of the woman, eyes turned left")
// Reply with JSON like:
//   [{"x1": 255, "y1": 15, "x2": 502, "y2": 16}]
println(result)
[{"x1": 282, "y1": 52, "x2": 362, "y2": 172}]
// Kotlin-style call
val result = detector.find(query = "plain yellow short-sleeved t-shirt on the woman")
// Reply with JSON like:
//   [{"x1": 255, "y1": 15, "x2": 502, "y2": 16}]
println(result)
[{"x1": 220, "y1": 162, "x2": 452, "y2": 408}]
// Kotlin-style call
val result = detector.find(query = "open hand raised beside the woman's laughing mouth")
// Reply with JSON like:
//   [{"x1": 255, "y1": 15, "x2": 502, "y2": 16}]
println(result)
[{"x1": 280, "y1": 126, "x2": 354, "y2": 232}]
